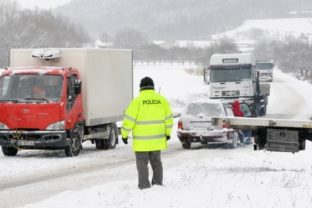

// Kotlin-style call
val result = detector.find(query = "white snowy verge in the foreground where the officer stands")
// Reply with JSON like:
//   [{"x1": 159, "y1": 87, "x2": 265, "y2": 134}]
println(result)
[{"x1": 24, "y1": 144, "x2": 312, "y2": 208}]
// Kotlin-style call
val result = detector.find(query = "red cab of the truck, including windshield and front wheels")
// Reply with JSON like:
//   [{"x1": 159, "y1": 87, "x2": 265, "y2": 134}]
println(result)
[{"x1": 0, "y1": 67, "x2": 84, "y2": 156}]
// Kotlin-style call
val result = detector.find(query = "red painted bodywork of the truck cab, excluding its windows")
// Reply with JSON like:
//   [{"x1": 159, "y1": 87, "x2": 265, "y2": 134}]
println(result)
[{"x1": 0, "y1": 67, "x2": 84, "y2": 130}]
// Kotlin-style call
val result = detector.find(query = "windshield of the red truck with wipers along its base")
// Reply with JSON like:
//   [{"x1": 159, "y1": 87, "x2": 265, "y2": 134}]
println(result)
[{"x1": 0, "y1": 74, "x2": 63, "y2": 102}]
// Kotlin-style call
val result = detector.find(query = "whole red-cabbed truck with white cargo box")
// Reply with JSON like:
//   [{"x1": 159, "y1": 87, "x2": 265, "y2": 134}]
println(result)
[{"x1": 0, "y1": 49, "x2": 133, "y2": 156}]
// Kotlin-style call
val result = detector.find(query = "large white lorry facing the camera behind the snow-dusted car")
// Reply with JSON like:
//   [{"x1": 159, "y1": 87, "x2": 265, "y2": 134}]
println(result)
[{"x1": 204, "y1": 53, "x2": 270, "y2": 116}]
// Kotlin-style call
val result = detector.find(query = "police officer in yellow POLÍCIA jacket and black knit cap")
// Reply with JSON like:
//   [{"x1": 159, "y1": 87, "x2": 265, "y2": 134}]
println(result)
[{"x1": 121, "y1": 77, "x2": 173, "y2": 189}]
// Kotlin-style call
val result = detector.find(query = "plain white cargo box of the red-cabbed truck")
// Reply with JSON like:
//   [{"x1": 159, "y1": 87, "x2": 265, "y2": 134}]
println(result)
[{"x1": 10, "y1": 48, "x2": 133, "y2": 126}]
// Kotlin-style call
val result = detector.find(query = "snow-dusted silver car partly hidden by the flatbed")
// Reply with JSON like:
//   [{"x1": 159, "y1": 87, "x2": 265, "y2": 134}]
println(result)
[{"x1": 177, "y1": 100, "x2": 239, "y2": 149}]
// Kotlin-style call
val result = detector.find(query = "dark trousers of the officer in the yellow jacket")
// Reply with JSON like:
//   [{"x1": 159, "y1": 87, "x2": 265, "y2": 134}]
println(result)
[{"x1": 135, "y1": 151, "x2": 163, "y2": 189}]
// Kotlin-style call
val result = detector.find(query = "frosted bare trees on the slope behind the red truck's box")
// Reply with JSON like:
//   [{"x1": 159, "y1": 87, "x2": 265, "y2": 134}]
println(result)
[{"x1": 0, "y1": 6, "x2": 90, "y2": 67}]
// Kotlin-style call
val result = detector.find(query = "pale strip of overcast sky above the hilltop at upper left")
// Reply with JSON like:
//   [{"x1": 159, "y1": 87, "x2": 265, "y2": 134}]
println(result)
[{"x1": 15, "y1": 0, "x2": 71, "y2": 9}]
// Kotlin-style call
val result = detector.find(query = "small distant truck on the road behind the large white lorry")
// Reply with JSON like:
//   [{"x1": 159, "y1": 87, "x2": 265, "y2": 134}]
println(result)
[{"x1": 255, "y1": 60, "x2": 274, "y2": 82}]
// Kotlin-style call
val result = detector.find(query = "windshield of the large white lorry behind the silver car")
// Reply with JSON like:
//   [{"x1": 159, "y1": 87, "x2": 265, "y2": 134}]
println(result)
[{"x1": 210, "y1": 66, "x2": 252, "y2": 82}]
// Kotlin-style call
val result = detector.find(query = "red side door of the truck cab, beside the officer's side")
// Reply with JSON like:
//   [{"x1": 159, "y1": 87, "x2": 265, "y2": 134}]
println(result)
[{"x1": 66, "y1": 74, "x2": 83, "y2": 129}]
